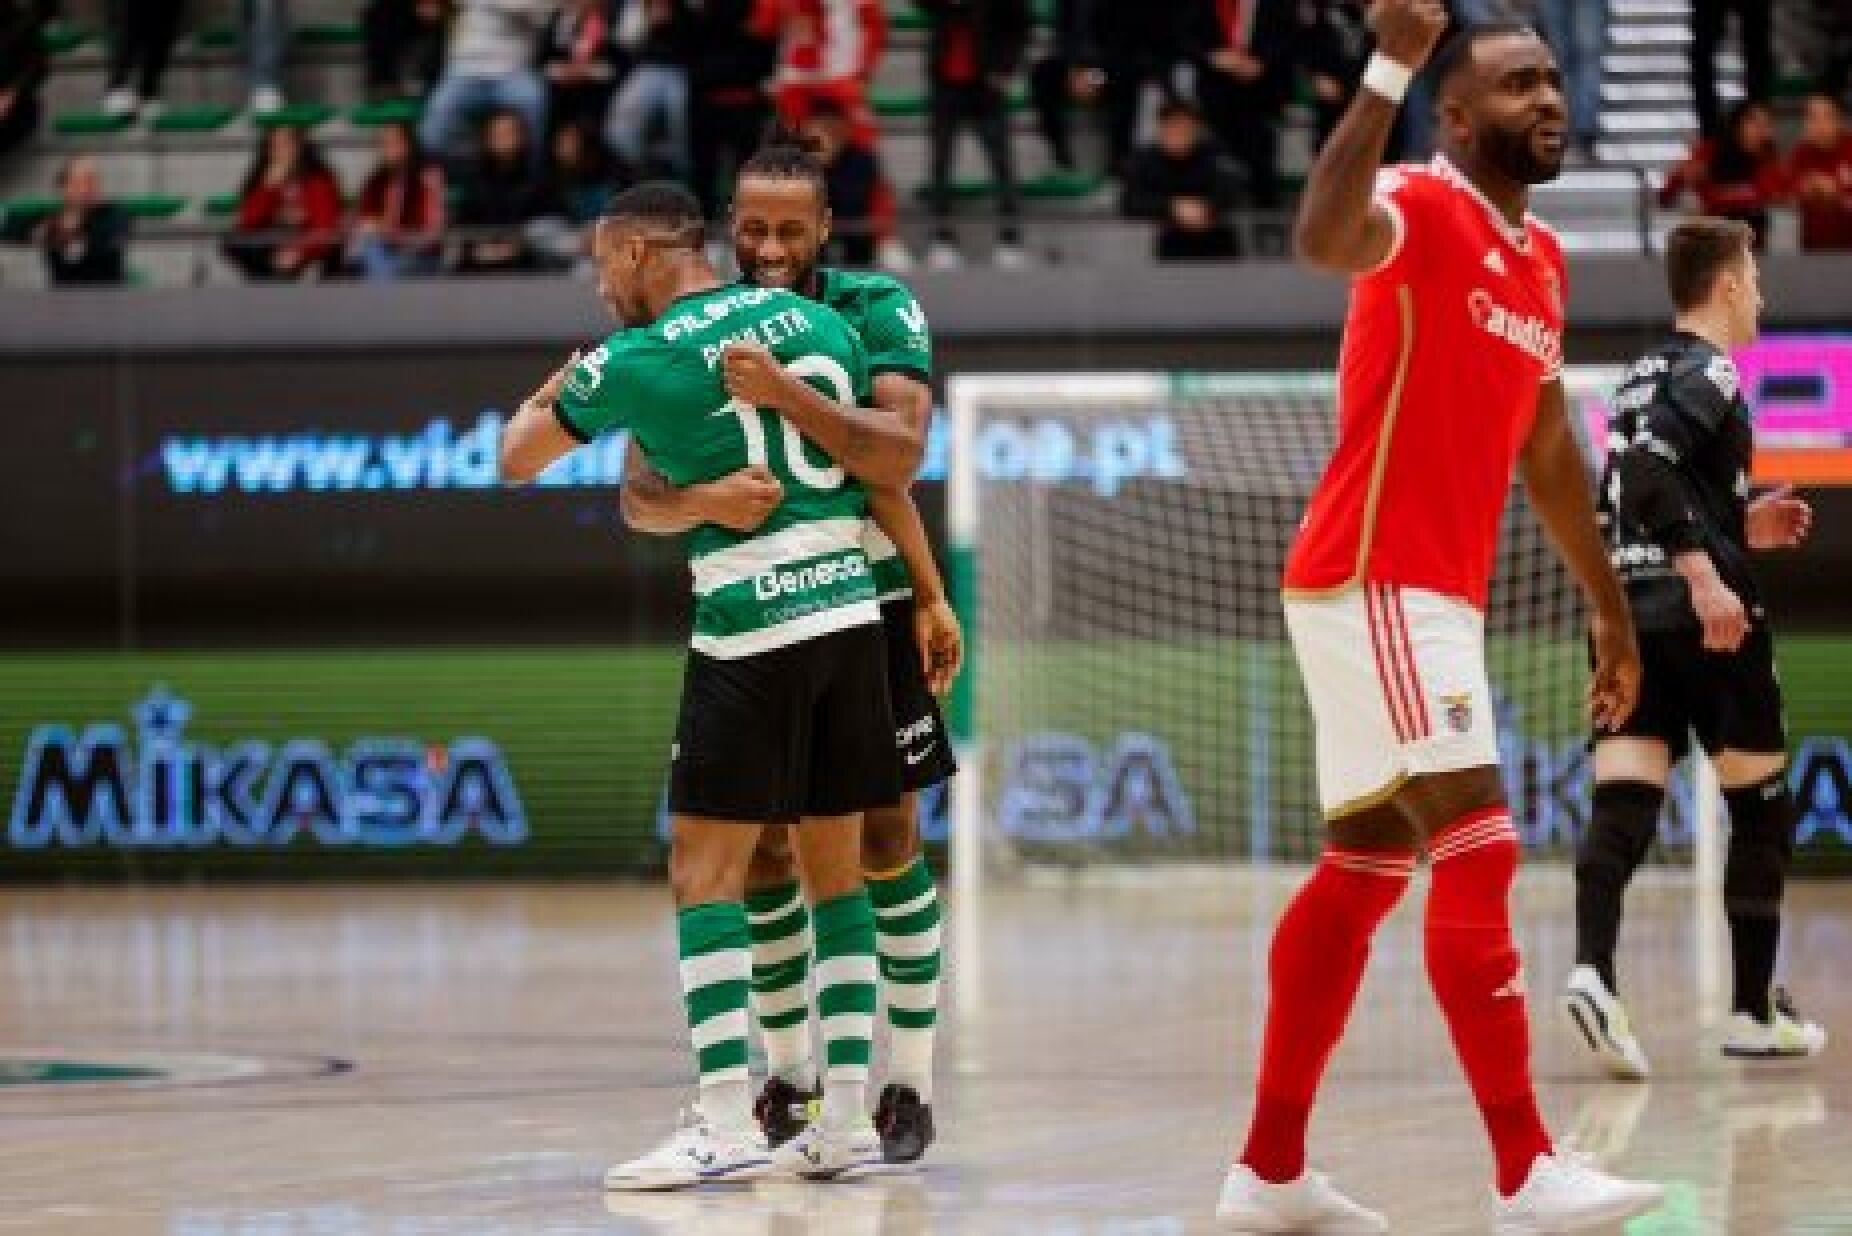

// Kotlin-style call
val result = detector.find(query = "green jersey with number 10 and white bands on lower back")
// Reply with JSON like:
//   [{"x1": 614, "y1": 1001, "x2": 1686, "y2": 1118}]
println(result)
[{"x1": 557, "y1": 284, "x2": 880, "y2": 658}]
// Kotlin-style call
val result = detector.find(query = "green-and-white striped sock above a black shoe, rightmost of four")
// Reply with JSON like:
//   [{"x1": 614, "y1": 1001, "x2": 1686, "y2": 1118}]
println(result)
[{"x1": 869, "y1": 856, "x2": 941, "y2": 1103}]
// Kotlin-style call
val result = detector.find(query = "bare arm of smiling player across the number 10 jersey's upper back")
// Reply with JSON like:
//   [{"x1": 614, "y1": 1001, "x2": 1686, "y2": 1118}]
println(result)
[{"x1": 720, "y1": 343, "x2": 932, "y2": 486}]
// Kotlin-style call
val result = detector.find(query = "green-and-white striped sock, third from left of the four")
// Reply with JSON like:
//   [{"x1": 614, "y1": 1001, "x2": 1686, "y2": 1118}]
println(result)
[{"x1": 815, "y1": 891, "x2": 874, "y2": 1127}]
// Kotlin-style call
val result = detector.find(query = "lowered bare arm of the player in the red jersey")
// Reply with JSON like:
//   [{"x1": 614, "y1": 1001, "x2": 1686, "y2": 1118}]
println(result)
[{"x1": 1519, "y1": 378, "x2": 1641, "y2": 730}]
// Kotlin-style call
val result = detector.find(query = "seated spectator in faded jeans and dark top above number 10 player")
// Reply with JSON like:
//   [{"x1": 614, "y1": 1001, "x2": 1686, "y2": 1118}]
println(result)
[{"x1": 604, "y1": 0, "x2": 695, "y2": 178}]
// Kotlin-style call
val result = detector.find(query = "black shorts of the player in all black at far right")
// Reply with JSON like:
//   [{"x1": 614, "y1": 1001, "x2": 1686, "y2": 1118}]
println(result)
[{"x1": 1596, "y1": 624, "x2": 1787, "y2": 763}]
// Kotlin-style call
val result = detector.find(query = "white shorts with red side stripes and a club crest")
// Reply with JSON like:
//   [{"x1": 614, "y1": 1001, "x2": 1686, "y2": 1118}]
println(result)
[{"x1": 1285, "y1": 584, "x2": 1498, "y2": 817}]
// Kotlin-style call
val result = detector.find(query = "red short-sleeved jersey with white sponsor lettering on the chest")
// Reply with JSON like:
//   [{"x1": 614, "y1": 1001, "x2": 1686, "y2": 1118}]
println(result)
[{"x1": 1285, "y1": 158, "x2": 1567, "y2": 610}]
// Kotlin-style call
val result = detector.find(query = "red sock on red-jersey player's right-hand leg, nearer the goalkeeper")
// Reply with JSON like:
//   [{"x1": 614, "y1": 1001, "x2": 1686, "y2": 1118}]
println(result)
[{"x1": 1426, "y1": 808, "x2": 1550, "y2": 1197}]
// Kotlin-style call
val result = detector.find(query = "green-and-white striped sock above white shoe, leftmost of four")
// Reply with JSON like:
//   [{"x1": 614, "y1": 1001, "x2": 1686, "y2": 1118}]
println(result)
[{"x1": 676, "y1": 901, "x2": 752, "y2": 1129}]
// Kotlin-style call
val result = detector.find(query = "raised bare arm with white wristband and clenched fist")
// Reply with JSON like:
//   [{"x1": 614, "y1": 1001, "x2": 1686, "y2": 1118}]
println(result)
[{"x1": 1293, "y1": 0, "x2": 1446, "y2": 274}]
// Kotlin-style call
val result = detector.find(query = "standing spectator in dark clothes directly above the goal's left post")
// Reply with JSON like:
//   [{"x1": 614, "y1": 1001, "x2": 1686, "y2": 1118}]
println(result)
[{"x1": 919, "y1": 0, "x2": 1030, "y2": 269}]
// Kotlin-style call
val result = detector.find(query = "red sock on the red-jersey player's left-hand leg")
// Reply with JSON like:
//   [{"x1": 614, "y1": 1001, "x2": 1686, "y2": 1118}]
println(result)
[{"x1": 1241, "y1": 851, "x2": 1415, "y2": 1184}]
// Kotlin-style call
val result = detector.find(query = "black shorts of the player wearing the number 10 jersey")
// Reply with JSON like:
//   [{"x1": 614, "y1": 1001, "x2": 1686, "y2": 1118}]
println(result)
[{"x1": 669, "y1": 623, "x2": 900, "y2": 821}]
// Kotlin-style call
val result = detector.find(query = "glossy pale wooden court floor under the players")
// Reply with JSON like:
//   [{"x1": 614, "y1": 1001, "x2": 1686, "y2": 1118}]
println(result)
[{"x1": 0, "y1": 867, "x2": 1852, "y2": 1236}]
